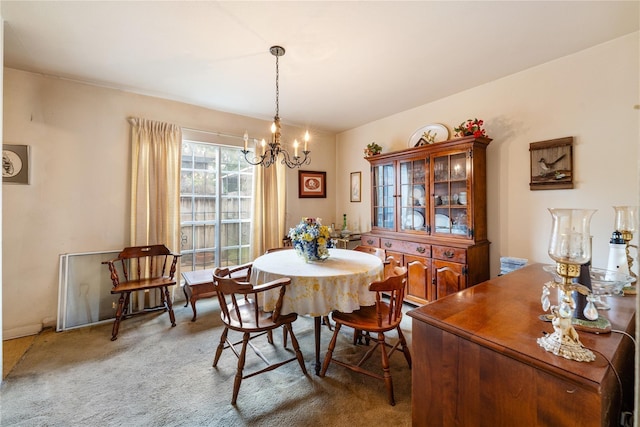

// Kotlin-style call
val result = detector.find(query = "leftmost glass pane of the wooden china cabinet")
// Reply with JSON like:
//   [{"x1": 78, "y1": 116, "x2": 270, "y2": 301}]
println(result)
[{"x1": 371, "y1": 163, "x2": 396, "y2": 230}]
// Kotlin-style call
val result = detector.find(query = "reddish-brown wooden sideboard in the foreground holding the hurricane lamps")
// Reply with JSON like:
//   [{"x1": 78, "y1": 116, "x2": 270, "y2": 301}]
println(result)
[{"x1": 408, "y1": 264, "x2": 636, "y2": 427}]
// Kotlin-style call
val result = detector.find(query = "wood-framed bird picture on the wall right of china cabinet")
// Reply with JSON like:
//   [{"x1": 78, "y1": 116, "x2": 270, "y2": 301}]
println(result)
[{"x1": 529, "y1": 136, "x2": 573, "y2": 190}]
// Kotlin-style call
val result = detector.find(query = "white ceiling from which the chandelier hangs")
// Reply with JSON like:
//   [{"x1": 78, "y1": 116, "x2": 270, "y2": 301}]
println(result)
[{"x1": 0, "y1": 0, "x2": 640, "y2": 131}]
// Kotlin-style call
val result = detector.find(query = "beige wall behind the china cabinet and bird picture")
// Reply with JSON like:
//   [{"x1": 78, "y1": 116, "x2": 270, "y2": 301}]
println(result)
[{"x1": 336, "y1": 33, "x2": 640, "y2": 276}]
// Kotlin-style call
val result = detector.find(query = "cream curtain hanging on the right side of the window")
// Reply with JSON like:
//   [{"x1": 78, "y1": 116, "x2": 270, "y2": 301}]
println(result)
[{"x1": 251, "y1": 162, "x2": 288, "y2": 259}]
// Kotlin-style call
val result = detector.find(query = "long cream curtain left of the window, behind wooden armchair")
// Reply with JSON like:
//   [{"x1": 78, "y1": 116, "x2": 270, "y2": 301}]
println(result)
[{"x1": 129, "y1": 118, "x2": 182, "y2": 309}]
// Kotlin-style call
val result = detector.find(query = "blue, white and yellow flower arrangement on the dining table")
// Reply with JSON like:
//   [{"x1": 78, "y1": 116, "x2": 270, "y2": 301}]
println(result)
[{"x1": 289, "y1": 218, "x2": 333, "y2": 262}]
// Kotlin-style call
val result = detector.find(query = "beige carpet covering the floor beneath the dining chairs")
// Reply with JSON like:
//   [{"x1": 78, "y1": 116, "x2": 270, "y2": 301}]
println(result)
[{"x1": 0, "y1": 299, "x2": 411, "y2": 426}]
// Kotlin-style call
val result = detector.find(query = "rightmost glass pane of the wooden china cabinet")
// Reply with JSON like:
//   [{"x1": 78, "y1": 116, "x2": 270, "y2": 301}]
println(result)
[{"x1": 431, "y1": 151, "x2": 470, "y2": 238}]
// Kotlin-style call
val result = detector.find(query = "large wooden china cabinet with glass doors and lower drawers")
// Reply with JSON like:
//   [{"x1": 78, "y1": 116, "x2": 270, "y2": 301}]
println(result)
[{"x1": 362, "y1": 136, "x2": 491, "y2": 304}]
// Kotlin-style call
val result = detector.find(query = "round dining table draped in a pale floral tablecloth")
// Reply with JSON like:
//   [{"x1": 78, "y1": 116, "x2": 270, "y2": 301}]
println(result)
[{"x1": 250, "y1": 248, "x2": 383, "y2": 375}]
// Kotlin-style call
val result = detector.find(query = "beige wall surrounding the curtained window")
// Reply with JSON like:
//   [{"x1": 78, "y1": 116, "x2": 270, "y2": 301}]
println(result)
[{"x1": 2, "y1": 69, "x2": 336, "y2": 339}]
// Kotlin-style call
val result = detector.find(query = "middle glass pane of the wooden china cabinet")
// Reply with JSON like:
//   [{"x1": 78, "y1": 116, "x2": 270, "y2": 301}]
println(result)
[{"x1": 398, "y1": 158, "x2": 429, "y2": 232}]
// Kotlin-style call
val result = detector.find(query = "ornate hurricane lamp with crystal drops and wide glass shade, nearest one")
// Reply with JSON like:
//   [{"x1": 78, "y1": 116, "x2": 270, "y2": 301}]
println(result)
[{"x1": 537, "y1": 209, "x2": 598, "y2": 362}]
